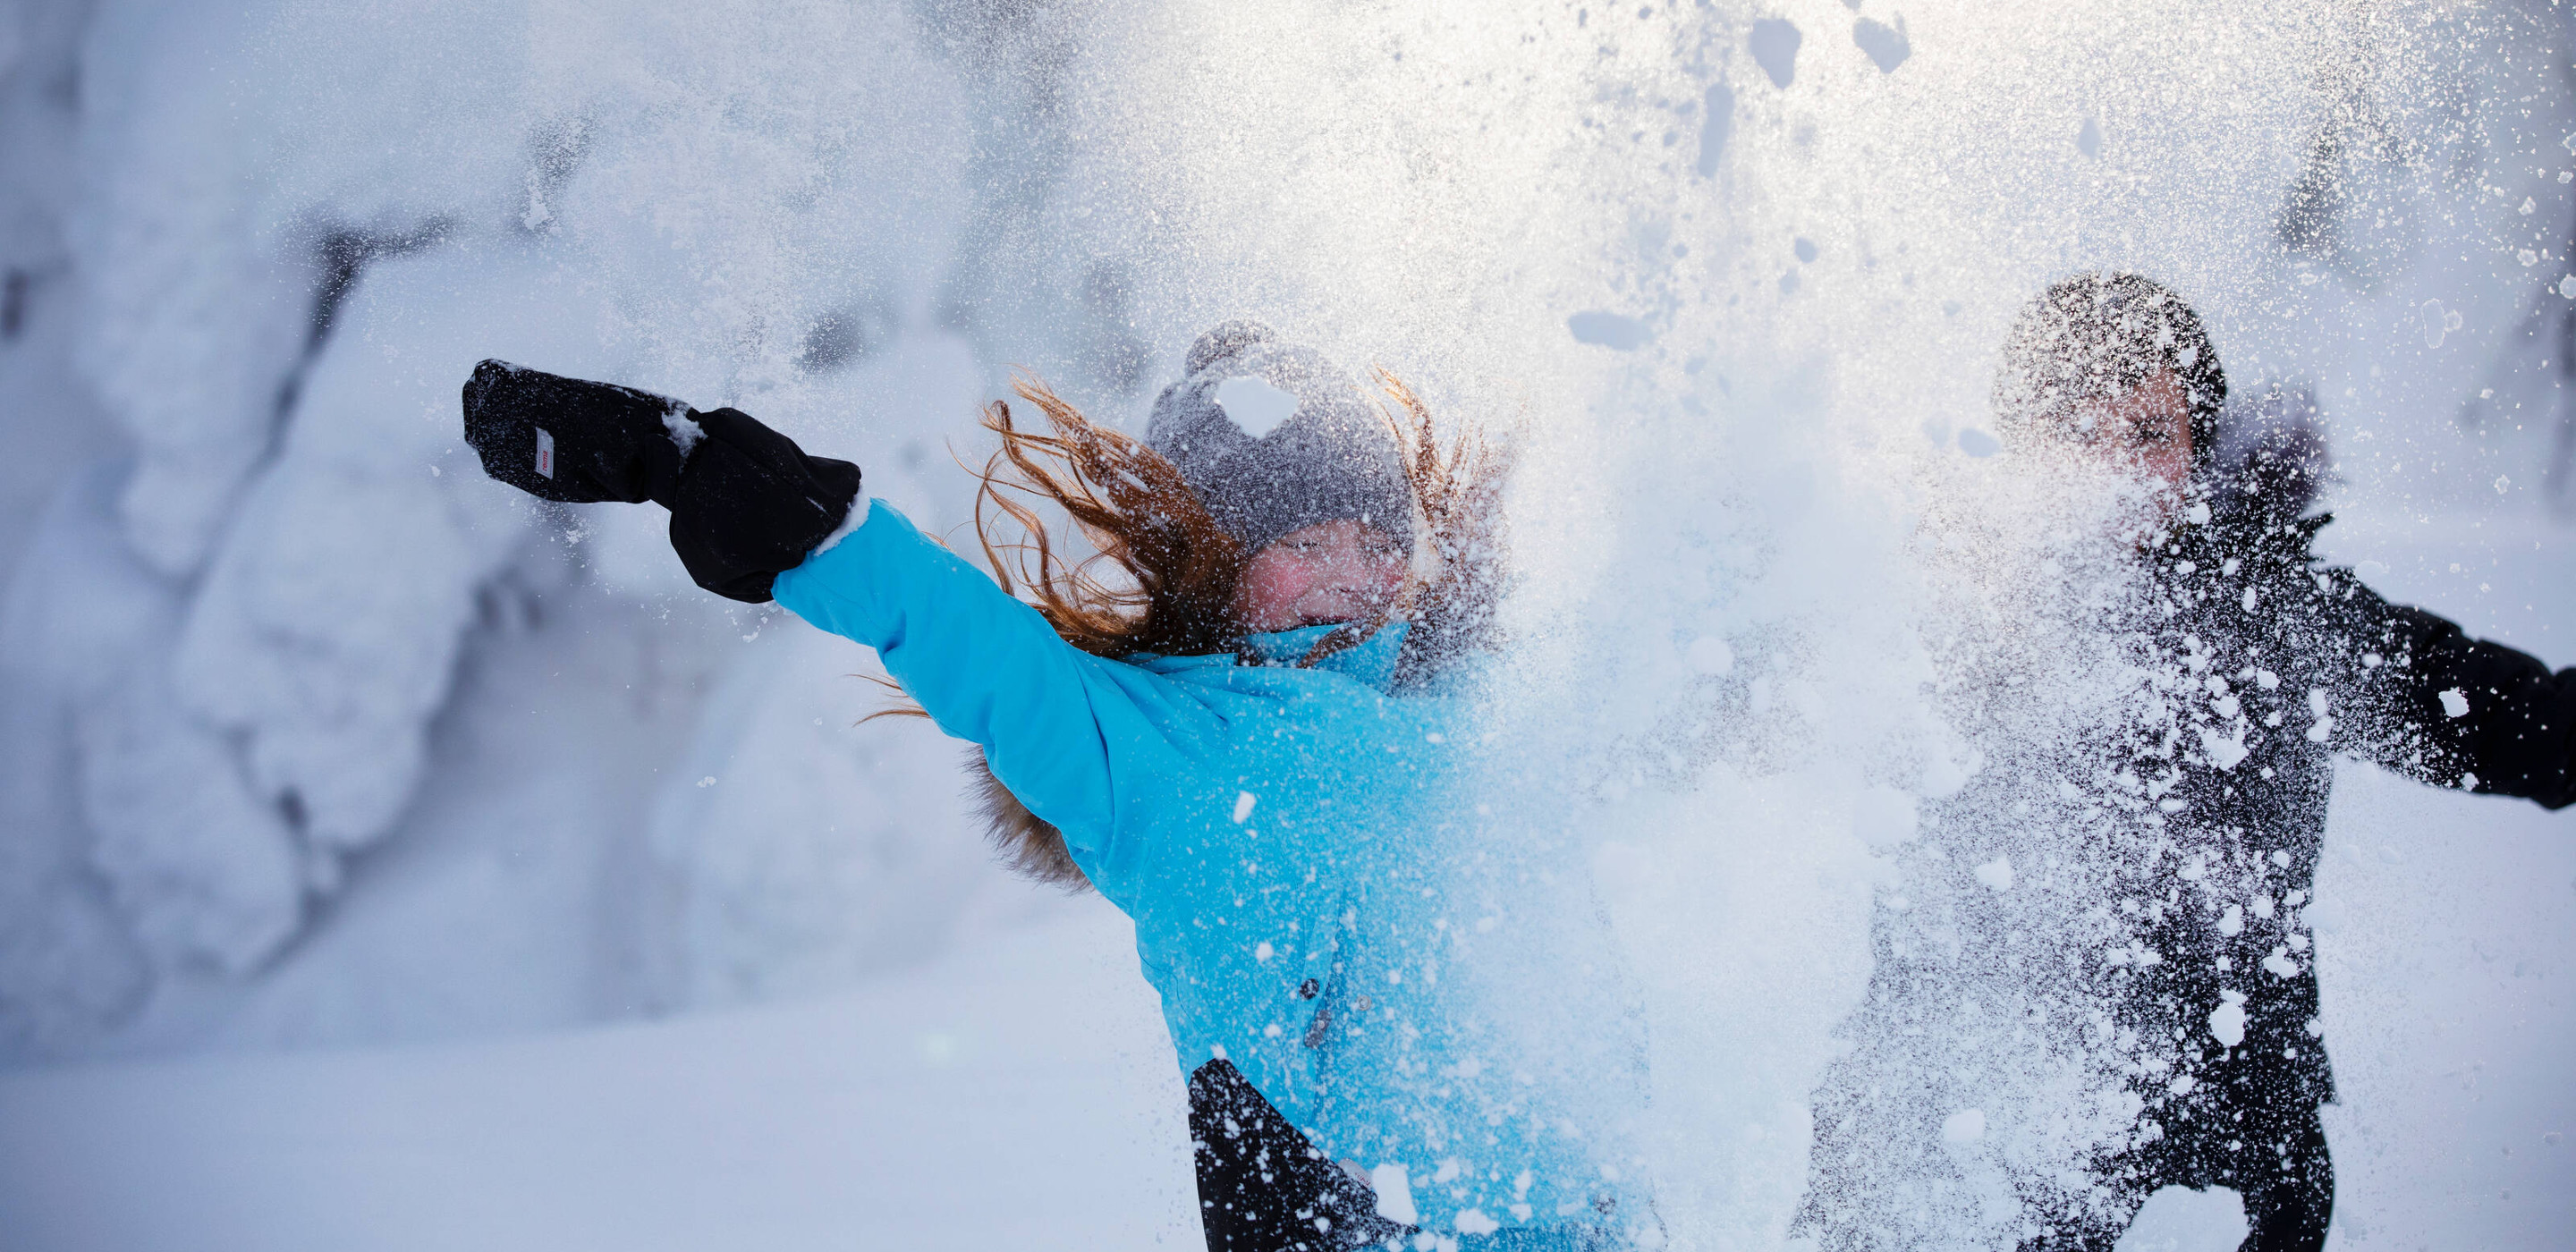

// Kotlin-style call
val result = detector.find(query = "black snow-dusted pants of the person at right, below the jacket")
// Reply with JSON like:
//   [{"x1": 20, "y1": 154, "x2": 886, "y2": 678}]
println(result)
[{"x1": 2020, "y1": 1105, "x2": 2334, "y2": 1252}]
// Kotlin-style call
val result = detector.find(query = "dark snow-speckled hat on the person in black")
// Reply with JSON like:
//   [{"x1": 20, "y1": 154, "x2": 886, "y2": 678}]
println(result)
[{"x1": 1994, "y1": 270, "x2": 2228, "y2": 464}]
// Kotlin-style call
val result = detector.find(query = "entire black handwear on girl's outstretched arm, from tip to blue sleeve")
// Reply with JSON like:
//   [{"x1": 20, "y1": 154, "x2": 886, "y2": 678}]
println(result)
[{"x1": 463, "y1": 360, "x2": 860, "y2": 605}]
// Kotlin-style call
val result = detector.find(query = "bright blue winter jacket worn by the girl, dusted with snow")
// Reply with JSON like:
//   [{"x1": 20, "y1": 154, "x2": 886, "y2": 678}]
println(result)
[{"x1": 775, "y1": 503, "x2": 1618, "y2": 1231}]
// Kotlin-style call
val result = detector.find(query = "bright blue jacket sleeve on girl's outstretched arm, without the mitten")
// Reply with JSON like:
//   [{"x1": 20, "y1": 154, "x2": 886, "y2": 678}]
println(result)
[{"x1": 773, "y1": 500, "x2": 1218, "y2": 858}]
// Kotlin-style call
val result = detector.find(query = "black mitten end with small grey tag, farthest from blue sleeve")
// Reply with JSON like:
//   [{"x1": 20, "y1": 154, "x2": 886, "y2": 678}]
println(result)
[{"x1": 463, "y1": 360, "x2": 698, "y2": 505}]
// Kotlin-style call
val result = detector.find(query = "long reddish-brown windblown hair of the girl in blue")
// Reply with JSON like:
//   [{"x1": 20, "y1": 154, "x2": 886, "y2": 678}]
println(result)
[{"x1": 917, "y1": 371, "x2": 1513, "y2": 892}]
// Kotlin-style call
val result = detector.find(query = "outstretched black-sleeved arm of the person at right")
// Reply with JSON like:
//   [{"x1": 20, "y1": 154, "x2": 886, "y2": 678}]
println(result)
[{"x1": 2318, "y1": 570, "x2": 2576, "y2": 809}]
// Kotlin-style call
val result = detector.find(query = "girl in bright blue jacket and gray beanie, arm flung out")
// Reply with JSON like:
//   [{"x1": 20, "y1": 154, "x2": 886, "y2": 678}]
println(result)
[{"x1": 463, "y1": 322, "x2": 1659, "y2": 1252}]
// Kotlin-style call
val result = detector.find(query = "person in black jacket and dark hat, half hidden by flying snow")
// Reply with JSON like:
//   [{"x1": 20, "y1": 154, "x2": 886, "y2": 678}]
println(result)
[{"x1": 1801, "y1": 273, "x2": 2576, "y2": 1252}]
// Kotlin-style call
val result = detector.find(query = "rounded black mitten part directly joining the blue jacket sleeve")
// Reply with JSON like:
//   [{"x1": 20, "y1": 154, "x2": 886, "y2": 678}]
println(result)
[{"x1": 659, "y1": 410, "x2": 860, "y2": 605}]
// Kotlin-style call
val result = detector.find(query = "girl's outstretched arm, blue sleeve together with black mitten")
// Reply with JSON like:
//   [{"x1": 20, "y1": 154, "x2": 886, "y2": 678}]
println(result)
[{"x1": 463, "y1": 360, "x2": 1216, "y2": 855}]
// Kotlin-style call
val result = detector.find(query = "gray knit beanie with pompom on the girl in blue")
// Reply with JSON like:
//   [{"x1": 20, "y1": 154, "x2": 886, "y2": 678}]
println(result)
[{"x1": 1144, "y1": 322, "x2": 1414, "y2": 556}]
